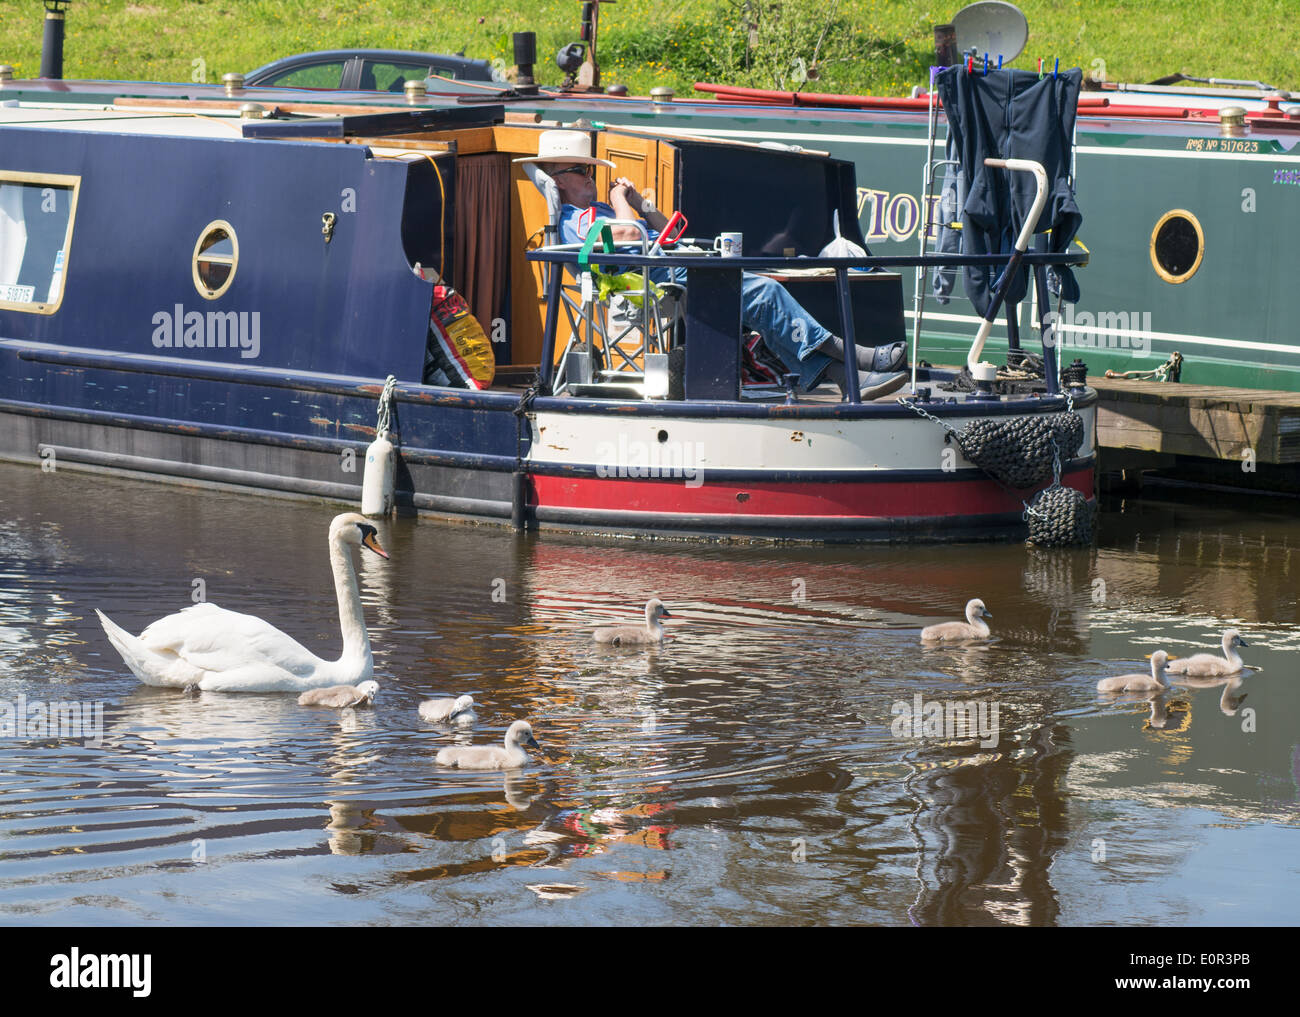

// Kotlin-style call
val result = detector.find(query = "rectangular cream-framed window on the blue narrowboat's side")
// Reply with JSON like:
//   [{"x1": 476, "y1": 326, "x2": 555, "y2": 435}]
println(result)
[{"x1": 0, "y1": 173, "x2": 81, "y2": 315}]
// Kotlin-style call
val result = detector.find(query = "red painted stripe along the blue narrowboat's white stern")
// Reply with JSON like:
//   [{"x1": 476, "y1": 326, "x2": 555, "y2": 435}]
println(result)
[{"x1": 533, "y1": 467, "x2": 1093, "y2": 519}]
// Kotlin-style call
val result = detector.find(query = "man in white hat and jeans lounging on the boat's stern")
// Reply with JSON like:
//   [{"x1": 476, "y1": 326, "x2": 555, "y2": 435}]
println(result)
[{"x1": 515, "y1": 130, "x2": 907, "y2": 399}]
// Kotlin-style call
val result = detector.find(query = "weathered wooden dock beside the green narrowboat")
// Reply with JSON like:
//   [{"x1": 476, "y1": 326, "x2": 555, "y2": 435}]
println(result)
[{"x1": 1088, "y1": 377, "x2": 1300, "y2": 490}]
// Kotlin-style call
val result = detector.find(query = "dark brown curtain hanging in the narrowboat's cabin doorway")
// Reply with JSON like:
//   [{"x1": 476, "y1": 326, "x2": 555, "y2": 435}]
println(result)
[{"x1": 452, "y1": 152, "x2": 510, "y2": 350}]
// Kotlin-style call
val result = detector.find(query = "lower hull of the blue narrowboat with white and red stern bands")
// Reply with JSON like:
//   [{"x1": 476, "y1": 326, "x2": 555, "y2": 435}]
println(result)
[{"x1": 0, "y1": 384, "x2": 1096, "y2": 542}]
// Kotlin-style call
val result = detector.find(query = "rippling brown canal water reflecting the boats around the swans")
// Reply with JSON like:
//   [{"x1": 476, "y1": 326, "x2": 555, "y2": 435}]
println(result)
[{"x1": 0, "y1": 466, "x2": 1300, "y2": 926}]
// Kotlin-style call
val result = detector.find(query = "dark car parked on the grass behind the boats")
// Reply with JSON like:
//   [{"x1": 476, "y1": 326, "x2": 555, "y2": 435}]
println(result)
[{"x1": 244, "y1": 49, "x2": 493, "y2": 92}]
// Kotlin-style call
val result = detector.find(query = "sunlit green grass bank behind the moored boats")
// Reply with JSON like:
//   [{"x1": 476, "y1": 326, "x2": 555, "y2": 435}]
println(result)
[{"x1": 0, "y1": 0, "x2": 1300, "y2": 95}]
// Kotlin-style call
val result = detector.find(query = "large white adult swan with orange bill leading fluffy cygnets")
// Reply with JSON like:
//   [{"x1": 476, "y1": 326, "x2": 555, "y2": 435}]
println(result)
[{"x1": 95, "y1": 512, "x2": 389, "y2": 692}]
